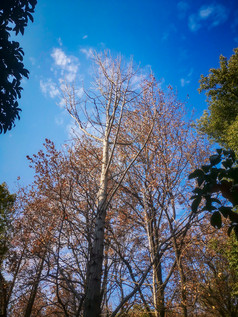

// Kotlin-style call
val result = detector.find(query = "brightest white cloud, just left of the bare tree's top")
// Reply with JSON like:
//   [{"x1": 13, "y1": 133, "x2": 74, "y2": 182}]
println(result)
[{"x1": 51, "y1": 48, "x2": 79, "y2": 82}]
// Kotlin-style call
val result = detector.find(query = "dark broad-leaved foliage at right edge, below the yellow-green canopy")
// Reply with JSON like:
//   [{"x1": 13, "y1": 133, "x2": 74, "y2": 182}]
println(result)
[{"x1": 189, "y1": 149, "x2": 238, "y2": 239}]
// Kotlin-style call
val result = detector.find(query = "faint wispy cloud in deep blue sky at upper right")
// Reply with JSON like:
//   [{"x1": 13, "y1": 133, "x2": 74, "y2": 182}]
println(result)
[{"x1": 188, "y1": 4, "x2": 229, "y2": 32}]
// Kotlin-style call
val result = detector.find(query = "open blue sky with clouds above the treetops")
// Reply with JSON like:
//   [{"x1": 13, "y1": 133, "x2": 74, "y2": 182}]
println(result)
[{"x1": 0, "y1": 0, "x2": 238, "y2": 192}]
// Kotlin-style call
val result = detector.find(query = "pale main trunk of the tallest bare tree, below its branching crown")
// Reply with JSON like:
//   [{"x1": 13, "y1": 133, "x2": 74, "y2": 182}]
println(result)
[{"x1": 84, "y1": 138, "x2": 109, "y2": 317}]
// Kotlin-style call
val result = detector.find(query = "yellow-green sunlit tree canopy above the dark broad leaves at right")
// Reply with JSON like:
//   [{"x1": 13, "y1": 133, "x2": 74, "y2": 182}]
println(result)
[{"x1": 198, "y1": 48, "x2": 238, "y2": 151}]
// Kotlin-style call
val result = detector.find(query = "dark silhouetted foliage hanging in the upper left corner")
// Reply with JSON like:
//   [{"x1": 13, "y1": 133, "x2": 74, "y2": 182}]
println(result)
[{"x1": 0, "y1": 0, "x2": 37, "y2": 133}]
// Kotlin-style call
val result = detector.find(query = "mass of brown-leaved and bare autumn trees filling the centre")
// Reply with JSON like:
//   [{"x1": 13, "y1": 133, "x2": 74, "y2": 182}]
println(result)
[{"x1": 0, "y1": 54, "x2": 237, "y2": 317}]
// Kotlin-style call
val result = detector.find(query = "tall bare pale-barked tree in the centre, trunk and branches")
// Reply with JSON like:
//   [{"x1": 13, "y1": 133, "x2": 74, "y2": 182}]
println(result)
[{"x1": 61, "y1": 53, "x2": 153, "y2": 317}]
